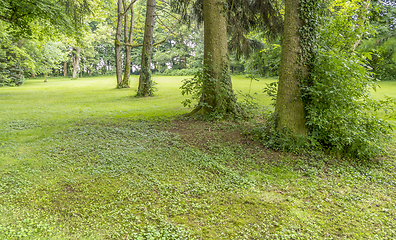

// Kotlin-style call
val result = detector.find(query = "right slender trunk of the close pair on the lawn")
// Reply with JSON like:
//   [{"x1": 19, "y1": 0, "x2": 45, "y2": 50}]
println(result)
[{"x1": 122, "y1": 0, "x2": 135, "y2": 88}]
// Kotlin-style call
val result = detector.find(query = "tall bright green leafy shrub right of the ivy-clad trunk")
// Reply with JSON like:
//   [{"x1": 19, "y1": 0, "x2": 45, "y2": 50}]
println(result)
[{"x1": 302, "y1": 1, "x2": 392, "y2": 158}]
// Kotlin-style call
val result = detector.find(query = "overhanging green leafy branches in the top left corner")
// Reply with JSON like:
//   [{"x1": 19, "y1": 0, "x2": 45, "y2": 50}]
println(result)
[{"x1": 0, "y1": 0, "x2": 92, "y2": 38}]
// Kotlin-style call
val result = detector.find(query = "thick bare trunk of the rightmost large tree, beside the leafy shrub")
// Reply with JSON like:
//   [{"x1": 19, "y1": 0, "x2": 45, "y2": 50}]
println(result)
[{"x1": 275, "y1": 0, "x2": 308, "y2": 135}]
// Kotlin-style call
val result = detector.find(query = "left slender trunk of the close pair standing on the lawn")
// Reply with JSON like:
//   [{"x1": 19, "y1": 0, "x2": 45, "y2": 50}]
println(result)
[{"x1": 115, "y1": 0, "x2": 123, "y2": 88}]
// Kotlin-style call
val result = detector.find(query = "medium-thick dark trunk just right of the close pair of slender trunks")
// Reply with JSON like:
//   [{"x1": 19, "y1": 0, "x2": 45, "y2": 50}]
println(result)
[{"x1": 137, "y1": 0, "x2": 155, "y2": 97}]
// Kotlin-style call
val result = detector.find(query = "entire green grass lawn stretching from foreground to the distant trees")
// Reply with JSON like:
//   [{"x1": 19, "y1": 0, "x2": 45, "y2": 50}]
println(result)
[{"x1": 0, "y1": 76, "x2": 396, "y2": 239}]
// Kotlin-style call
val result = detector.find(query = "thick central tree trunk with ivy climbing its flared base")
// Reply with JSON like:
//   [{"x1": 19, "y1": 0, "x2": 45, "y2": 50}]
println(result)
[{"x1": 190, "y1": 0, "x2": 236, "y2": 116}]
